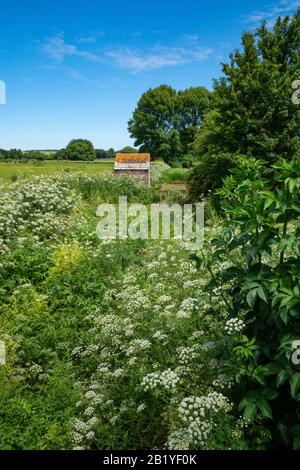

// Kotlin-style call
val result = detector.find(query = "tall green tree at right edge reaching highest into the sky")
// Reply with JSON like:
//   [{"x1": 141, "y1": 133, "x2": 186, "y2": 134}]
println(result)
[{"x1": 194, "y1": 10, "x2": 300, "y2": 164}]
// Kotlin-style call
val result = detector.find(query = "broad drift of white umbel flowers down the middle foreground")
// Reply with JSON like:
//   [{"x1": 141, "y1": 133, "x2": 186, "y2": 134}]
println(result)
[{"x1": 62, "y1": 243, "x2": 240, "y2": 449}]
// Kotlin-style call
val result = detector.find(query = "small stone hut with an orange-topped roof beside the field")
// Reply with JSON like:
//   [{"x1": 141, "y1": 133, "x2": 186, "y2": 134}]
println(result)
[{"x1": 115, "y1": 153, "x2": 150, "y2": 184}]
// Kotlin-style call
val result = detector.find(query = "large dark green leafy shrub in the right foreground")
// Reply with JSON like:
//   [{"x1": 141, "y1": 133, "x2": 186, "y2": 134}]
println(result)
[{"x1": 201, "y1": 158, "x2": 300, "y2": 449}]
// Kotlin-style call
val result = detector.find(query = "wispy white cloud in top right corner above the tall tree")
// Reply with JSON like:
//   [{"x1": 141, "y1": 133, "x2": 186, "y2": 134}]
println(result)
[{"x1": 244, "y1": 0, "x2": 300, "y2": 26}]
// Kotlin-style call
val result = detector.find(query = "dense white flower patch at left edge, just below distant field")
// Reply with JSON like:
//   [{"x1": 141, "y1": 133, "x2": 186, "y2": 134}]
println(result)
[{"x1": 0, "y1": 177, "x2": 79, "y2": 254}]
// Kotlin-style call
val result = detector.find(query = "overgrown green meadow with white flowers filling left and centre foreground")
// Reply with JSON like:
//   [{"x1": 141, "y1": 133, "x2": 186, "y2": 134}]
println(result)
[{"x1": 0, "y1": 175, "x2": 258, "y2": 449}]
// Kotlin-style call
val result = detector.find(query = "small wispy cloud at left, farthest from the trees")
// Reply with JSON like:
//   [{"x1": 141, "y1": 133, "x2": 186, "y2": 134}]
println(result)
[{"x1": 40, "y1": 34, "x2": 101, "y2": 64}]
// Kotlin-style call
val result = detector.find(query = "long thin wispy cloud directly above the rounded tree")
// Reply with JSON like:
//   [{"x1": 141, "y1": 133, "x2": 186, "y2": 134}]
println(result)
[{"x1": 105, "y1": 45, "x2": 212, "y2": 73}]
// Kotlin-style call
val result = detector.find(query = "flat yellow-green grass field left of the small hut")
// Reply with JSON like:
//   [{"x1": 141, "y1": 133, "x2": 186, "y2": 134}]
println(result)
[{"x1": 0, "y1": 159, "x2": 114, "y2": 182}]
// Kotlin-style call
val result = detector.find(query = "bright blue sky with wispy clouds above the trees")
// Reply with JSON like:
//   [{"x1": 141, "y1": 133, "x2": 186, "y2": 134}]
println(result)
[{"x1": 0, "y1": 0, "x2": 300, "y2": 149}]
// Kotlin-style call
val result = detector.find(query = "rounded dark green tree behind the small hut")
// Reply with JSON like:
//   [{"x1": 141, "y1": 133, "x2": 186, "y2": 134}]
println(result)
[{"x1": 128, "y1": 85, "x2": 211, "y2": 164}]
